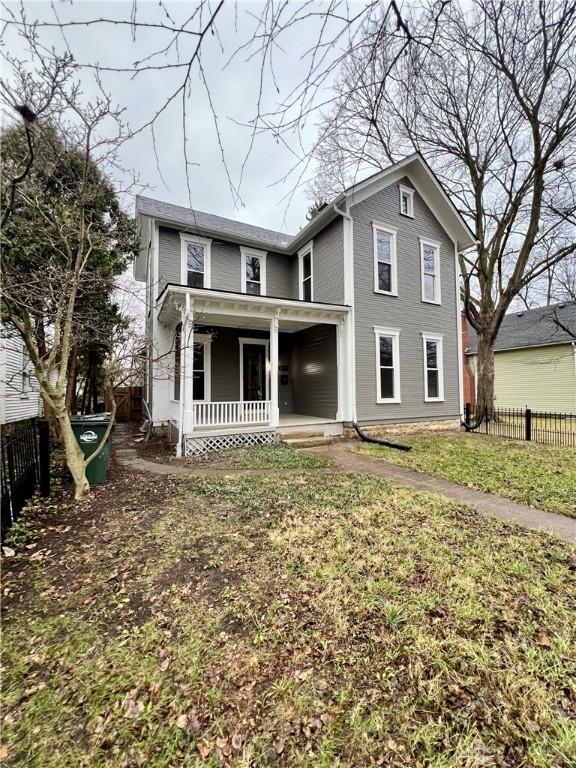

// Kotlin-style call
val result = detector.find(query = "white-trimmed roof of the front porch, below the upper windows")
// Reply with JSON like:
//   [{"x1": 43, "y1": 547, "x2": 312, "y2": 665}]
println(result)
[{"x1": 156, "y1": 283, "x2": 351, "y2": 331}]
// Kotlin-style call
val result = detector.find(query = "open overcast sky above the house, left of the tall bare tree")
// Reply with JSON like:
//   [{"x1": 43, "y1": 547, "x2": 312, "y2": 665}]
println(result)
[{"x1": 3, "y1": 0, "x2": 352, "y2": 233}]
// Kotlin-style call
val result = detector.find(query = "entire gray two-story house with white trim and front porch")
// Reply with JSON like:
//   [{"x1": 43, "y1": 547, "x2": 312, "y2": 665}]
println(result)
[{"x1": 134, "y1": 155, "x2": 474, "y2": 454}]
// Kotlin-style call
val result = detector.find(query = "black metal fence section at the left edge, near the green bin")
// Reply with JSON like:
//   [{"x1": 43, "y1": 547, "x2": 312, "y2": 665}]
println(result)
[{"x1": 0, "y1": 419, "x2": 50, "y2": 541}]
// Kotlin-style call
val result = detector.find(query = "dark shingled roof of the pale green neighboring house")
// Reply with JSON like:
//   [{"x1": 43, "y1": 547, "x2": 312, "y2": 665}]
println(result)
[{"x1": 467, "y1": 302, "x2": 576, "y2": 355}]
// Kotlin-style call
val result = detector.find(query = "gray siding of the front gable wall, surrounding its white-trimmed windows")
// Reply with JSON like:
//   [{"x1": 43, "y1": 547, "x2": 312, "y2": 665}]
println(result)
[{"x1": 351, "y1": 178, "x2": 459, "y2": 421}]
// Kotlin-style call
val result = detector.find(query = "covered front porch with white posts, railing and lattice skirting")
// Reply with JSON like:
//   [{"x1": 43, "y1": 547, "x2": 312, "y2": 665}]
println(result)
[{"x1": 158, "y1": 286, "x2": 349, "y2": 450}]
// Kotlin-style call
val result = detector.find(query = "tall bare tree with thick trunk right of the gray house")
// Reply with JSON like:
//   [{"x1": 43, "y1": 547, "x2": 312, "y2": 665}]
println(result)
[{"x1": 313, "y1": 0, "x2": 576, "y2": 415}]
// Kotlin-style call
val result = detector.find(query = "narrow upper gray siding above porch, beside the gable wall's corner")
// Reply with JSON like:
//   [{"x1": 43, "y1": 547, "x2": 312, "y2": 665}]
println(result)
[{"x1": 312, "y1": 218, "x2": 344, "y2": 304}]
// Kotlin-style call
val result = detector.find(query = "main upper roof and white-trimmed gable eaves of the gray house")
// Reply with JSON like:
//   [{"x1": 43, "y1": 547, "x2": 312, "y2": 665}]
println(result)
[{"x1": 136, "y1": 153, "x2": 475, "y2": 253}]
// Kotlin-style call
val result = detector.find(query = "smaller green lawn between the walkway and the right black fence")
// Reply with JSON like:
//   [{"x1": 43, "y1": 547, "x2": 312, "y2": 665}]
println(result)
[{"x1": 359, "y1": 433, "x2": 576, "y2": 517}]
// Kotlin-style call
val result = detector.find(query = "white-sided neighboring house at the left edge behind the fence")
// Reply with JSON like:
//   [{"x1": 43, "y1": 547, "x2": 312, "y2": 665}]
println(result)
[{"x1": 0, "y1": 328, "x2": 42, "y2": 424}]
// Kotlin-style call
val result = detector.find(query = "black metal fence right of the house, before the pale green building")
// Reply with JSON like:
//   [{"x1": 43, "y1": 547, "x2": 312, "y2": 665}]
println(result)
[{"x1": 465, "y1": 403, "x2": 576, "y2": 448}]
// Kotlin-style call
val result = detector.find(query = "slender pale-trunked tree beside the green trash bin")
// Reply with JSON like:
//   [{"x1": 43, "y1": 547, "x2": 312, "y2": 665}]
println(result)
[{"x1": 1, "y1": 54, "x2": 137, "y2": 499}]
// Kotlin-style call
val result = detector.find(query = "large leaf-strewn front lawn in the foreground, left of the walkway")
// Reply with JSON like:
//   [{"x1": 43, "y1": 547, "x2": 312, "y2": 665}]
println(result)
[{"x1": 2, "y1": 460, "x2": 576, "y2": 768}]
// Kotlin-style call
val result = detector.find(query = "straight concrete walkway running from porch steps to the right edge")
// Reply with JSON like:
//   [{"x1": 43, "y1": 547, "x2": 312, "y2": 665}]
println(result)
[{"x1": 308, "y1": 444, "x2": 576, "y2": 543}]
